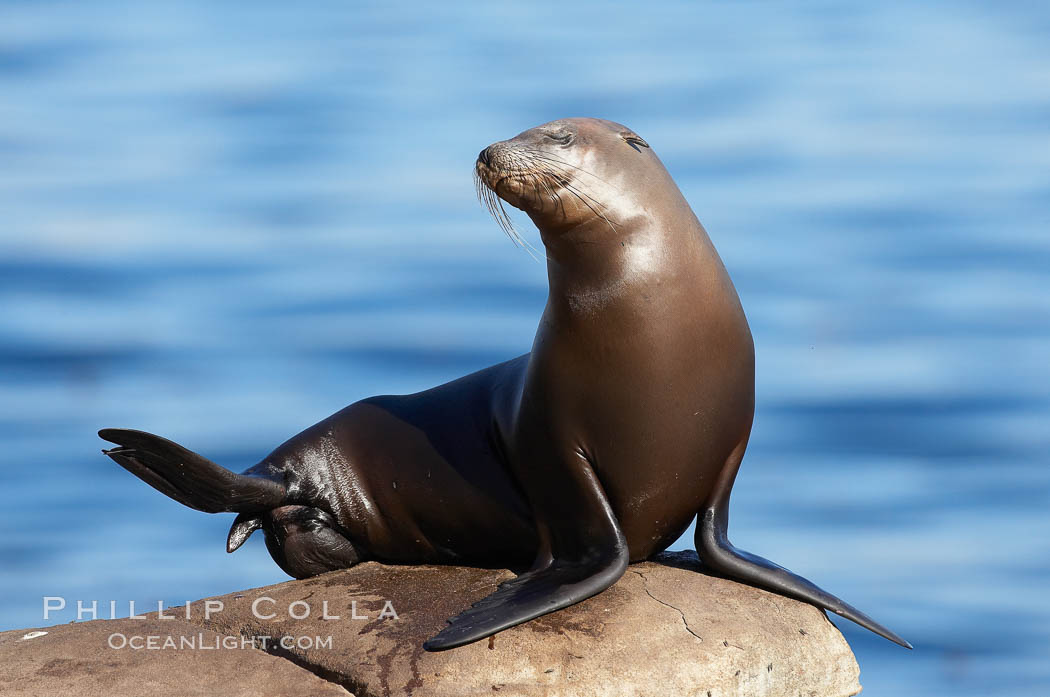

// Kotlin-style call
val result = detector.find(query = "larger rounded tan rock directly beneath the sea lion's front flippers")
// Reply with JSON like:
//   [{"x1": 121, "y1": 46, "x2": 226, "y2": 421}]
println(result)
[{"x1": 184, "y1": 552, "x2": 860, "y2": 697}]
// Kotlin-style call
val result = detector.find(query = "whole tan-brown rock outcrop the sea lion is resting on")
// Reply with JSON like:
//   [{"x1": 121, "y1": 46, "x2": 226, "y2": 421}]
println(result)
[{"x1": 0, "y1": 553, "x2": 860, "y2": 697}]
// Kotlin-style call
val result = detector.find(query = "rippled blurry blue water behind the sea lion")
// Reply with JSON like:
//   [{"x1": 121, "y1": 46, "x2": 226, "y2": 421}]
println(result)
[{"x1": 0, "y1": 0, "x2": 1050, "y2": 697}]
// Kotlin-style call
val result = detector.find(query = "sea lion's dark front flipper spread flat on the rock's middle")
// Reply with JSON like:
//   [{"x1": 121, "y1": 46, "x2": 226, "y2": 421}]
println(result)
[{"x1": 423, "y1": 546, "x2": 628, "y2": 651}]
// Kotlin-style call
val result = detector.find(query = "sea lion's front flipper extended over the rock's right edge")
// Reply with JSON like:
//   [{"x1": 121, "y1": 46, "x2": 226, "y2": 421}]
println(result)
[{"x1": 696, "y1": 509, "x2": 912, "y2": 649}]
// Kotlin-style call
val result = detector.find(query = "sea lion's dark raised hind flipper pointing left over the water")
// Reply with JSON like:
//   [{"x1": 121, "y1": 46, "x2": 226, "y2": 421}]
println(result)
[{"x1": 99, "y1": 428, "x2": 286, "y2": 514}]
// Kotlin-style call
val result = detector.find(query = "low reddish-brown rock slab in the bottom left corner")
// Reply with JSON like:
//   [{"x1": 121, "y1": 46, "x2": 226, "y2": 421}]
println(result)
[{"x1": 0, "y1": 619, "x2": 350, "y2": 697}]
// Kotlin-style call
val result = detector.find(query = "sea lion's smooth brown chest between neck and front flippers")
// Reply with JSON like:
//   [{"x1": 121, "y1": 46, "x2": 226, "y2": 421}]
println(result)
[{"x1": 523, "y1": 248, "x2": 754, "y2": 558}]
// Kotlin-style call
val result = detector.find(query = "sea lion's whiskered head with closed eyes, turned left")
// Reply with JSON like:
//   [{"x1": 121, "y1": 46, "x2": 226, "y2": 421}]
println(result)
[{"x1": 475, "y1": 119, "x2": 663, "y2": 241}]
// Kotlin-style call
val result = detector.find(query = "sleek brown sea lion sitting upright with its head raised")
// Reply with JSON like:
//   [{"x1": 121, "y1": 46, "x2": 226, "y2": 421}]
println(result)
[{"x1": 100, "y1": 119, "x2": 910, "y2": 651}]
